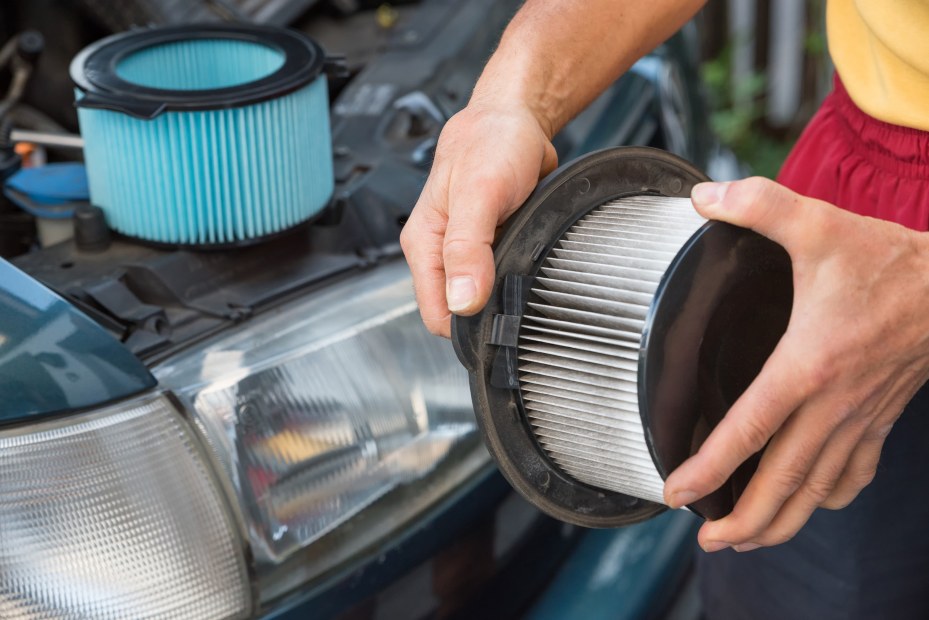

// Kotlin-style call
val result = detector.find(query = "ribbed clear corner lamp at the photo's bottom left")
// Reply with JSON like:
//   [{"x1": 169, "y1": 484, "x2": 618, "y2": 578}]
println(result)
[{"x1": 0, "y1": 396, "x2": 252, "y2": 620}]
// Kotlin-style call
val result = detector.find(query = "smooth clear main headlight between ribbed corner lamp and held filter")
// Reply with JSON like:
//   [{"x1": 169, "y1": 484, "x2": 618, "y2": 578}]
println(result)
[{"x1": 154, "y1": 261, "x2": 486, "y2": 598}]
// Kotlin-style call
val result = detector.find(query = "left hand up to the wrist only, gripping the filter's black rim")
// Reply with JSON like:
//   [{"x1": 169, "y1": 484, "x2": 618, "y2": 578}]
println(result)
[{"x1": 400, "y1": 103, "x2": 557, "y2": 337}]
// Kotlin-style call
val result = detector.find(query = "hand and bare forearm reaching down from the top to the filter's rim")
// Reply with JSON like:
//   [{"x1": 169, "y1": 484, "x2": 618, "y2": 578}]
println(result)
[{"x1": 400, "y1": 0, "x2": 706, "y2": 336}]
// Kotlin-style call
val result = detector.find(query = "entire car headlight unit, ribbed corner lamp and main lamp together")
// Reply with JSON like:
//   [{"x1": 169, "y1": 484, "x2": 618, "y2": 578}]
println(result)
[{"x1": 0, "y1": 261, "x2": 490, "y2": 620}]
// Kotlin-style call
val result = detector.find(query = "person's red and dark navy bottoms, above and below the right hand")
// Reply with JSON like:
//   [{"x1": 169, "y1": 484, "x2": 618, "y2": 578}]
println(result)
[{"x1": 697, "y1": 80, "x2": 929, "y2": 620}]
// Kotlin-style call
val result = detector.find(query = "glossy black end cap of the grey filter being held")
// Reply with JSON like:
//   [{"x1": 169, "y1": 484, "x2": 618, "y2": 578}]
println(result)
[{"x1": 639, "y1": 222, "x2": 793, "y2": 519}]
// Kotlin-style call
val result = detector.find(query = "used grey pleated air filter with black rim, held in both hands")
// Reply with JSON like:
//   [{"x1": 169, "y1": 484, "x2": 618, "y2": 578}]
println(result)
[{"x1": 452, "y1": 148, "x2": 793, "y2": 527}]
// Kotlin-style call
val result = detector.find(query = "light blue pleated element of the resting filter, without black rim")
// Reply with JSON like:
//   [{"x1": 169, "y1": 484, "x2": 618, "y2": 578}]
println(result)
[{"x1": 72, "y1": 35, "x2": 334, "y2": 245}]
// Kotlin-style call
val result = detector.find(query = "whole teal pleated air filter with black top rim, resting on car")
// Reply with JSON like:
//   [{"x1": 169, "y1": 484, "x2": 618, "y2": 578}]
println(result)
[{"x1": 71, "y1": 25, "x2": 333, "y2": 246}]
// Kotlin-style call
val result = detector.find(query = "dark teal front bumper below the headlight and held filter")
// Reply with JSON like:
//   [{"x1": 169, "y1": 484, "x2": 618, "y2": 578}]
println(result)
[{"x1": 265, "y1": 468, "x2": 698, "y2": 620}]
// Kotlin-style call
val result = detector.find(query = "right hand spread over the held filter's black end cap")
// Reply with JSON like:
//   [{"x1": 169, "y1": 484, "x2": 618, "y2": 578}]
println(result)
[{"x1": 665, "y1": 179, "x2": 929, "y2": 551}]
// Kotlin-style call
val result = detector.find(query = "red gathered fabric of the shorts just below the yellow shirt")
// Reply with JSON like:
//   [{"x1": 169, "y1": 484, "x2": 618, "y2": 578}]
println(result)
[{"x1": 777, "y1": 77, "x2": 929, "y2": 230}]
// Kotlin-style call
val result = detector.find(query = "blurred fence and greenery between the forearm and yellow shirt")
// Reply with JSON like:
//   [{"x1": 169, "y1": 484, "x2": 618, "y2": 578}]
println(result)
[{"x1": 701, "y1": 0, "x2": 832, "y2": 178}]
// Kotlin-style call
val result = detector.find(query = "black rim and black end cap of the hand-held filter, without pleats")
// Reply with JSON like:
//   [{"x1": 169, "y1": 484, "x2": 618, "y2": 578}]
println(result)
[{"x1": 452, "y1": 147, "x2": 793, "y2": 527}]
